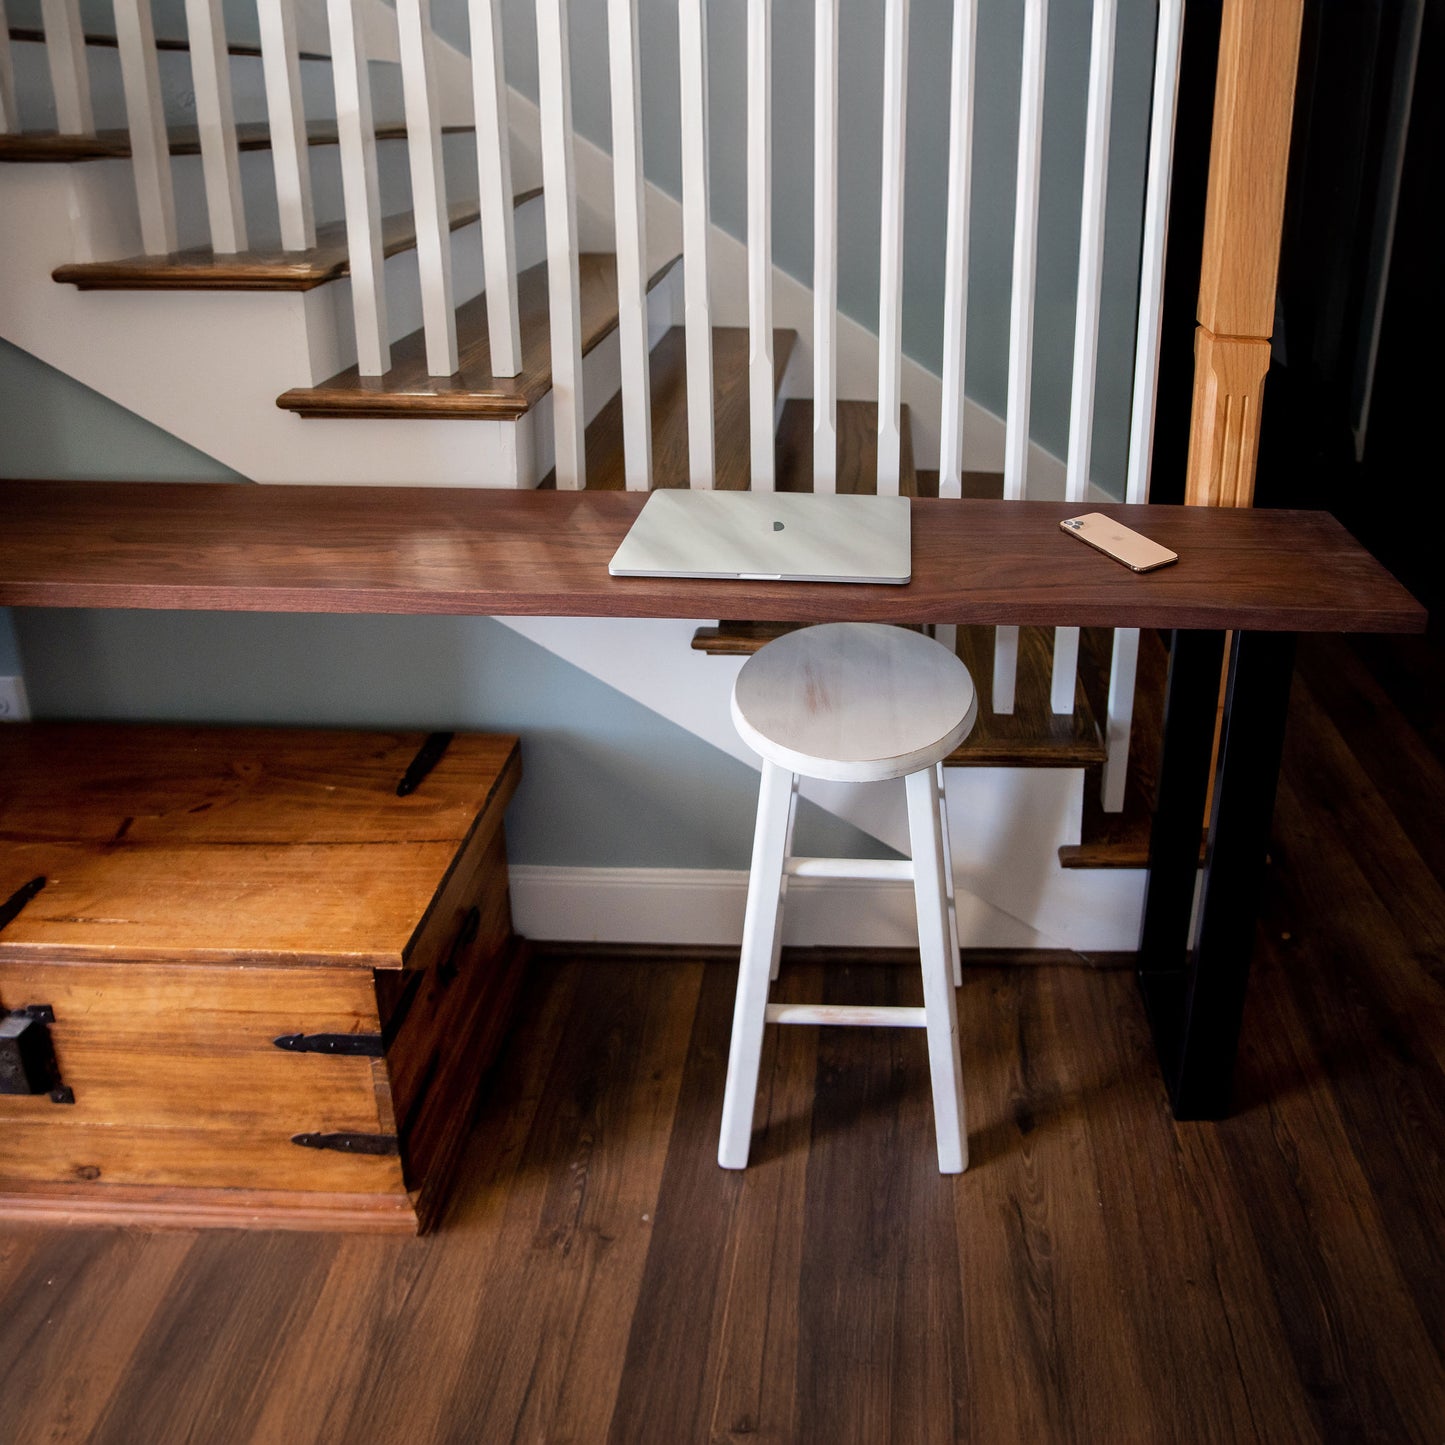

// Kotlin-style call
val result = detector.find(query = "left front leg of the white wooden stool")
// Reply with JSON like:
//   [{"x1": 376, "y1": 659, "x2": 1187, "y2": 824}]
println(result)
[{"x1": 718, "y1": 762, "x2": 793, "y2": 1169}]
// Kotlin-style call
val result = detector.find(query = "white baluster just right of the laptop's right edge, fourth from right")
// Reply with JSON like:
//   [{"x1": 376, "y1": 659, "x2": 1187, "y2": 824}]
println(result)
[{"x1": 938, "y1": 0, "x2": 978, "y2": 497}]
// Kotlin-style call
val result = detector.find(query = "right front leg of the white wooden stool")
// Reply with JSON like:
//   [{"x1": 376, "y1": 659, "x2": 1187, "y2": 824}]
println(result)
[{"x1": 907, "y1": 767, "x2": 968, "y2": 1173}]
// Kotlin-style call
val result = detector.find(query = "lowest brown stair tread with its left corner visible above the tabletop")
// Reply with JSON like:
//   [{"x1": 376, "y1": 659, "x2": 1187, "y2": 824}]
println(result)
[{"x1": 276, "y1": 251, "x2": 676, "y2": 420}]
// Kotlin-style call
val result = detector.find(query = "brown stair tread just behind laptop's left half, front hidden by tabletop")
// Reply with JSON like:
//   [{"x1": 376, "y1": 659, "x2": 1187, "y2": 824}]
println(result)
[{"x1": 542, "y1": 327, "x2": 798, "y2": 491}]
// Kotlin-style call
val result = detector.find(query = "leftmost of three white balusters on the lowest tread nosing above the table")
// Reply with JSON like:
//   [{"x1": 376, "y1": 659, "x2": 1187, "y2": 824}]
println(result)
[{"x1": 327, "y1": 0, "x2": 392, "y2": 376}]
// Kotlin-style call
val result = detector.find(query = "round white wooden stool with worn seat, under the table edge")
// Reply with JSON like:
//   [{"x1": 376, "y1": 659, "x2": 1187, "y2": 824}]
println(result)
[{"x1": 718, "y1": 623, "x2": 978, "y2": 1173}]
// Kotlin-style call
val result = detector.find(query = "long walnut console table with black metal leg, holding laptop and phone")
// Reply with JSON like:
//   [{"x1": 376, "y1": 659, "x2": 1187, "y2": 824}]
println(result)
[{"x1": 0, "y1": 481, "x2": 1426, "y2": 1118}]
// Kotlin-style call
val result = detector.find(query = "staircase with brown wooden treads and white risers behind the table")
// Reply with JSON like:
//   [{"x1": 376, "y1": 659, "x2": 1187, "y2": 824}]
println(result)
[{"x1": 0, "y1": 0, "x2": 1190, "y2": 946}]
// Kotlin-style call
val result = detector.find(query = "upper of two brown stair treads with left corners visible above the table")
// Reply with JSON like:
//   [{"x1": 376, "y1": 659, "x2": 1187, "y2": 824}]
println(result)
[{"x1": 51, "y1": 188, "x2": 542, "y2": 290}]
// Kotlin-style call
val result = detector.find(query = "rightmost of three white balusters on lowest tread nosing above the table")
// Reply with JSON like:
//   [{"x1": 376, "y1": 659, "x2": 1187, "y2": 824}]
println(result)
[{"x1": 470, "y1": 0, "x2": 522, "y2": 376}]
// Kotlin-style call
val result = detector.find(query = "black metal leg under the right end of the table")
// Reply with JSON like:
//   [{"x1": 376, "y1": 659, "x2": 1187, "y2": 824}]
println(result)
[{"x1": 1139, "y1": 633, "x2": 1295, "y2": 1120}]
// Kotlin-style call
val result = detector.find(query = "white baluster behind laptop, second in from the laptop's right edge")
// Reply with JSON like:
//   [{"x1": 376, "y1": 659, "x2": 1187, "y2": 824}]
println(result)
[{"x1": 814, "y1": 0, "x2": 838, "y2": 491}]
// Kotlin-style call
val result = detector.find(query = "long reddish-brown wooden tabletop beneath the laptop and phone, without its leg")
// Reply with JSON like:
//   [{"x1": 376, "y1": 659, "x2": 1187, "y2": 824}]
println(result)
[{"x1": 0, "y1": 481, "x2": 1425, "y2": 631}]
